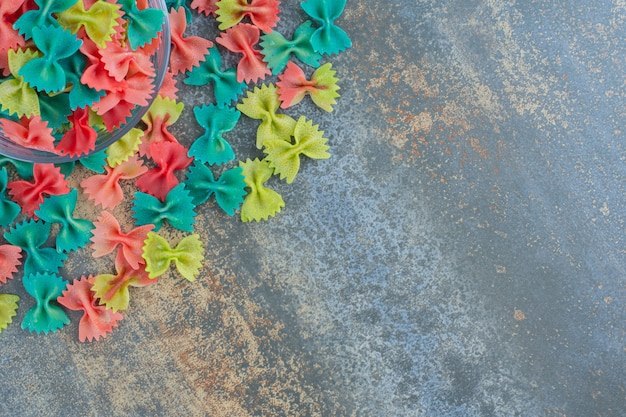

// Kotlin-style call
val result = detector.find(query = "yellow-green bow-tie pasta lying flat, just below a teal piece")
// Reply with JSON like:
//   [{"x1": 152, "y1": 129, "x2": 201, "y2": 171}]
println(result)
[{"x1": 143, "y1": 232, "x2": 204, "y2": 281}]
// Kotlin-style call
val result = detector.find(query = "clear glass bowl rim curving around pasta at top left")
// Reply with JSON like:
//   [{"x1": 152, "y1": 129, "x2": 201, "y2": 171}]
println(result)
[{"x1": 0, "y1": 0, "x2": 171, "y2": 164}]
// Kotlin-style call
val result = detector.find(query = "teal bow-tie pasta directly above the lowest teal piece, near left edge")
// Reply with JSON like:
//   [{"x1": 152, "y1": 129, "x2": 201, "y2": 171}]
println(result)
[{"x1": 4, "y1": 219, "x2": 67, "y2": 275}]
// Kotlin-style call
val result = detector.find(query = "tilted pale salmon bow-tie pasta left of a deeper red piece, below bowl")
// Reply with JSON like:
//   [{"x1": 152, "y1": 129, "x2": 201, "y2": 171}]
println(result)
[{"x1": 80, "y1": 155, "x2": 148, "y2": 209}]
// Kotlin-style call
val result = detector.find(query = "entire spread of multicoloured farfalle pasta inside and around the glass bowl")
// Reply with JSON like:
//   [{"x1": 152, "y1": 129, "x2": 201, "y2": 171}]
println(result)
[{"x1": 0, "y1": 0, "x2": 350, "y2": 342}]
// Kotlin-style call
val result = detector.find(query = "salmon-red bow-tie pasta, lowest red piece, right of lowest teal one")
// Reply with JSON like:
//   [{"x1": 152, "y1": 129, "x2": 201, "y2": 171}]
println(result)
[{"x1": 57, "y1": 275, "x2": 122, "y2": 342}]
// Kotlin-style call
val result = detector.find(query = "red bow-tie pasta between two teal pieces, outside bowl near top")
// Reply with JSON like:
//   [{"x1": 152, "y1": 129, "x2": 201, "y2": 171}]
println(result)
[{"x1": 215, "y1": 23, "x2": 272, "y2": 82}]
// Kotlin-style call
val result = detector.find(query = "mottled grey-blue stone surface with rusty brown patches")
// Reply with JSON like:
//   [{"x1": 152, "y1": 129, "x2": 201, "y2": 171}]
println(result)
[{"x1": 0, "y1": 0, "x2": 626, "y2": 417}]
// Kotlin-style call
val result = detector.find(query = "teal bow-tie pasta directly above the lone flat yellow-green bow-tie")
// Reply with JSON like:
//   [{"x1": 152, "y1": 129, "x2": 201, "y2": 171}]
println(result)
[{"x1": 133, "y1": 183, "x2": 196, "y2": 232}]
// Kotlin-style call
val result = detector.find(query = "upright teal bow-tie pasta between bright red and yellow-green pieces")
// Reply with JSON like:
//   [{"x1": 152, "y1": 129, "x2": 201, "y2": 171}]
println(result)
[{"x1": 189, "y1": 104, "x2": 241, "y2": 165}]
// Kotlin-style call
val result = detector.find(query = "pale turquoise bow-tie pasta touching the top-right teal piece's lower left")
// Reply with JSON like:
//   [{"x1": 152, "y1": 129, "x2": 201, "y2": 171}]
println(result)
[{"x1": 260, "y1": 20, "x2": 322, "y2": 75}]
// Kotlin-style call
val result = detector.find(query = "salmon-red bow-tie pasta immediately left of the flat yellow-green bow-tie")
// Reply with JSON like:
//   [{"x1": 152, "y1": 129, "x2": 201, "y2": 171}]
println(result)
[{"x1": 91, "y1": 211, "x2": 154, "y2": 269}]
